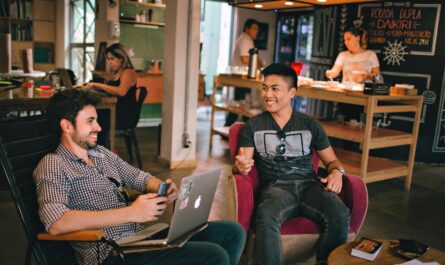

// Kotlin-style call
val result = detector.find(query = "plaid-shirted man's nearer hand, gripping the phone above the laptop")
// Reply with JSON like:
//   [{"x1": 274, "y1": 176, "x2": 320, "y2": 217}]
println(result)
[{"x1": 129, "y1": 193, "x2": 170, "y2": 223}]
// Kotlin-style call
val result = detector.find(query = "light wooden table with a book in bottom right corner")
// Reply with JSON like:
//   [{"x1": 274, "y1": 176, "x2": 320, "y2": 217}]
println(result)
[{"x1": 328, "y1": 239, "x2": 445, "y2": 265}]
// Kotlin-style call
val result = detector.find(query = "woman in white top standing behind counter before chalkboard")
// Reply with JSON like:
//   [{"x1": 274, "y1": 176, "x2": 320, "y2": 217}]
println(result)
[{"x1": 326, "y1": 28, "x2": 380, "y2": 83}]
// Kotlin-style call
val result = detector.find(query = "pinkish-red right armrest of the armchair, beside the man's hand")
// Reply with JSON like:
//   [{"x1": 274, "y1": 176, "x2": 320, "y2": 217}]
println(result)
[{"x1": 340, "y1": 175, "x2": 368, "y2": 234}]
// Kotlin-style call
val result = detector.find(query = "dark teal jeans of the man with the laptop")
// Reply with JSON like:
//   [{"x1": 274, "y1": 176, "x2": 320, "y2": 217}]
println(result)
[{"x1": 104, "y1": 221, "x2": 246, "y2": 265}]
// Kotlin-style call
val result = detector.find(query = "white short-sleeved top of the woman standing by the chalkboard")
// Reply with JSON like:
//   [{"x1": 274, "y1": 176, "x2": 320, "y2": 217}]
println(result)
[{"x1": 335, "y1": 50, "x2": 380, "y2": 83}]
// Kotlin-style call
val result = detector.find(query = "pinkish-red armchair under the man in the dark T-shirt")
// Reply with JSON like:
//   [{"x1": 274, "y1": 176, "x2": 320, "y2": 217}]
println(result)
[{"x1": 229, "y1": 123, "x2": 368, "y2": 264}]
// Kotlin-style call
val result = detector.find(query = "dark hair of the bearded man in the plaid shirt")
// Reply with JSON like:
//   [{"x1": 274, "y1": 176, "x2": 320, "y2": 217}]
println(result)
[{"x1": 46, "y1": 89, "x2": 100, "y2": 136}]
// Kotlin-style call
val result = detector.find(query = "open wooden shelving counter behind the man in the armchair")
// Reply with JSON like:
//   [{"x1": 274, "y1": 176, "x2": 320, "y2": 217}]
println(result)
[{"x1": 210, "y1": 75, "x2": 423, "y2": 190}]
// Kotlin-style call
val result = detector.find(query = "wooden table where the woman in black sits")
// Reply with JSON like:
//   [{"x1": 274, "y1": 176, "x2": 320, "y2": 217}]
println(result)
[{"x1": 0, "y1": 88, "x2": 117, "y2": 152}]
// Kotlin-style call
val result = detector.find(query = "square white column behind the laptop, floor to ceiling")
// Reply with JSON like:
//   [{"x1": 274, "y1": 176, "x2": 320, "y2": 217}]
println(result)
[{"x1": 159, "y1": 0, "x2": 200, "y2": 168}]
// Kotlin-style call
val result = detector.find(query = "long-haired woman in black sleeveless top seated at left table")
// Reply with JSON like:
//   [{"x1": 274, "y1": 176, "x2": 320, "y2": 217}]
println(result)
[{"x1": 82, "y1": 43, "x2": 138, "y2": 147}]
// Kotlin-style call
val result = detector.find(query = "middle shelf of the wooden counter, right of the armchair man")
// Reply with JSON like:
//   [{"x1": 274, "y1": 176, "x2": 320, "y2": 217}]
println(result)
[{"x1": 320, "y1": 121, "x2": 414, "y2": 149}]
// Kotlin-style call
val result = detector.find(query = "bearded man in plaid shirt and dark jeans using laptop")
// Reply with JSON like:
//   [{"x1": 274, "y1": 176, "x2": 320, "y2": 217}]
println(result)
[{"x1": 34, "y1": 89, "x2": 245, "y2": 265}]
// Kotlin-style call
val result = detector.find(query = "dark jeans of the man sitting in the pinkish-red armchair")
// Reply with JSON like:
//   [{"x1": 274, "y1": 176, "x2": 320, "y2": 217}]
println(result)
[{"x1": 255, "y1": 179, "x2": 350, "y2": 265}]
